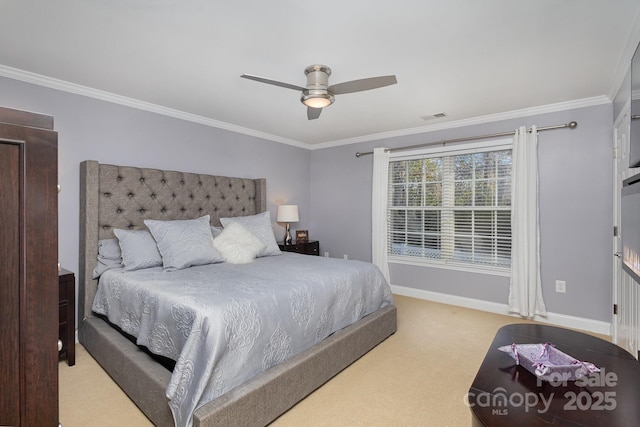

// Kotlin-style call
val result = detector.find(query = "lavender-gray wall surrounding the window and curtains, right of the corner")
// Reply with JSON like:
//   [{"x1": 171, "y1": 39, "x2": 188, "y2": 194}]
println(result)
[{"x1": 311, "y1": 104, "x2": 613, "y2": 322}]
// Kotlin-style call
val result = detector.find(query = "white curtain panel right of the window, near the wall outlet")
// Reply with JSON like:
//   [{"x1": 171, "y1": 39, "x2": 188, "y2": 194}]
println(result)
[{"x1": 509, "y1": 126, "x2": 547, "y2": 318}]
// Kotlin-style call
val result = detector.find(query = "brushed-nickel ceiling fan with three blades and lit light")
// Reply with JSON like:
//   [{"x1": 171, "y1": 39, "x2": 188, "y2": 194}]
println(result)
[{"x1": 240, "y1": 65, "x2": 398, "y2": 120}]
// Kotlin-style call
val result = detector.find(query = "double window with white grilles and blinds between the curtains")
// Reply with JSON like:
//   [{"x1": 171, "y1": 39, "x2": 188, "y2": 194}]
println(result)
[{"x1": 387, "y1": 141, "x2": 511, "y2": 268}]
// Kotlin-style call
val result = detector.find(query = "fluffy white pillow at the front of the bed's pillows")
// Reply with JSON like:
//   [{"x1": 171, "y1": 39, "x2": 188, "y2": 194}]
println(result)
[{"x1": 213, "y1": 222, "x2": 264, "y2": 264}]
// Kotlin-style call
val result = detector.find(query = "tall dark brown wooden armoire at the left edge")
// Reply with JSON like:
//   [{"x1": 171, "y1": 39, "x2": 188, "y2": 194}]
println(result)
[{"x1": 0, "y1": 107, "x2": 58, "y2": 426}]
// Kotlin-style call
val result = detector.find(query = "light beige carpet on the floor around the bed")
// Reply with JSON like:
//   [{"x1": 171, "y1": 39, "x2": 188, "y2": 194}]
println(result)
[{"x1": 59, "y1": 295, "x2": 588, "y2": 427}]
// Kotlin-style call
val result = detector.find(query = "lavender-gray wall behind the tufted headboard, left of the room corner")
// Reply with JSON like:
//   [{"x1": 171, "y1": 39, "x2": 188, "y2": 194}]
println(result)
[{"x1": 0, "y1": 77, "x2": 310, "y2": 288}]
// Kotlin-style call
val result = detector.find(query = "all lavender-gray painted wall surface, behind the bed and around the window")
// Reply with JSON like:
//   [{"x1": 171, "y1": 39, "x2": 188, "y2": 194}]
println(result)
[{"x1": 0, "y1": 77, "x2": 613, "y2": 322}]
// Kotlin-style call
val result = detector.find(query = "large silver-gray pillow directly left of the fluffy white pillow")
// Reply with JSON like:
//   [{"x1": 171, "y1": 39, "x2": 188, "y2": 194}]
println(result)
[{"x1": 144, "y1": 215, "x2": 224, "y2": 271}]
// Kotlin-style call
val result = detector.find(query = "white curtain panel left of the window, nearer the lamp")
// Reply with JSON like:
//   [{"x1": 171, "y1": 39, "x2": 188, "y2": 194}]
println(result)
[{"x1": 371, "y1": 148, "x2": 390, "y2": 283}]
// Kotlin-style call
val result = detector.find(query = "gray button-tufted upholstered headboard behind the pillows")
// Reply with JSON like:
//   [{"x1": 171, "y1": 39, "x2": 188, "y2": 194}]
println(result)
[{"x1": 78, "y1": 160, "x2": 267, "y2": 321}]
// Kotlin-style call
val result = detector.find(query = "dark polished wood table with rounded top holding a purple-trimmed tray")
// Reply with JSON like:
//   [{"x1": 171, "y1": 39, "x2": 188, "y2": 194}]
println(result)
[{"x1": 468, "y1": 324, "x2": 640, "y2": 427}]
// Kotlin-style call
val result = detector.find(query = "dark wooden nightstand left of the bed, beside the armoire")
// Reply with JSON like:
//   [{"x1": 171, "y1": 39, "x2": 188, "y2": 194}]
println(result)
[{"x1": 58, "y1": 268, "x2": 76, "y2": 366}]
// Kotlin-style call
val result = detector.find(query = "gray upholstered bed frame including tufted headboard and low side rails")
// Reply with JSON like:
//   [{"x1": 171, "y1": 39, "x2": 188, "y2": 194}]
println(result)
[{"x1": 78, "y1": 160, "x2": 396, "y2": 426}]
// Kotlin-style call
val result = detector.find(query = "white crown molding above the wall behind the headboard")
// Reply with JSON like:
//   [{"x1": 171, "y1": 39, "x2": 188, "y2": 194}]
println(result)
[{"x1": 0, "y1": 65, "x2": 308, "y2": 148}]
